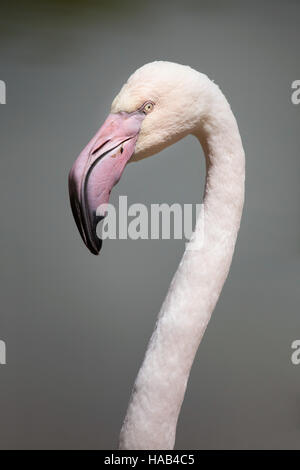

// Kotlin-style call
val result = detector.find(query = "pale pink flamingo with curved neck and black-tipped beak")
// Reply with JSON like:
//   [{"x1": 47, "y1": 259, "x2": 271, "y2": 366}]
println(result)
[{"x1": 69, "y1": 61, "x2": 245, "y2": 450}]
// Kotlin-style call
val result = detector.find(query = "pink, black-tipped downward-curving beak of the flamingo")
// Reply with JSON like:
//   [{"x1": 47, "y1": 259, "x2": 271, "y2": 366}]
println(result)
[{"x1": 69, "y1": 111, "x2": 145, "y2": 255}]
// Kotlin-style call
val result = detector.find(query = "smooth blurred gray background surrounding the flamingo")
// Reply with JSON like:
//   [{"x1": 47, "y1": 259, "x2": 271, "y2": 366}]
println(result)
[{"x1": 0, "y1": 0, "x2": 300, "y2": 449}]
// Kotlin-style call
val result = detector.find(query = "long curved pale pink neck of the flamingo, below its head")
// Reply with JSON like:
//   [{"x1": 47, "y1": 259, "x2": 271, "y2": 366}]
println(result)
[{"x1": 120, "y1": 82, "x2": 245, "y2": 450}]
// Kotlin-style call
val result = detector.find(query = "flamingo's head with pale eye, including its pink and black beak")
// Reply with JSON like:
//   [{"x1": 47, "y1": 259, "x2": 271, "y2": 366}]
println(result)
[{"x1": 69, "y1": 61, "x2": 206, "y2": 255}]
